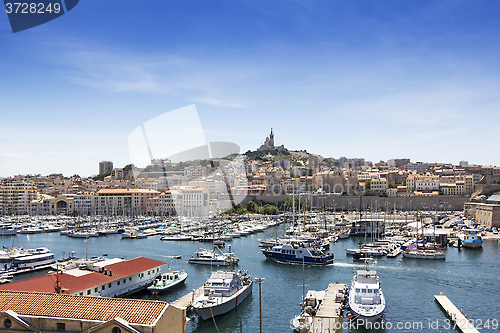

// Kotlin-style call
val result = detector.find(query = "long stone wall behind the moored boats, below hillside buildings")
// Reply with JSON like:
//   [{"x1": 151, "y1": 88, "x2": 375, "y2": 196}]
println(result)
[{"x1": 234, "y1": 194, "x2": 470, "y2": 211}]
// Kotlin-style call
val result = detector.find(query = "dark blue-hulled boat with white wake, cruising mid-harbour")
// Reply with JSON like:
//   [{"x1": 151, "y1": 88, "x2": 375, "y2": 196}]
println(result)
[{"x1": 261, "y1": 244, "x2": 333, "y2": 265}]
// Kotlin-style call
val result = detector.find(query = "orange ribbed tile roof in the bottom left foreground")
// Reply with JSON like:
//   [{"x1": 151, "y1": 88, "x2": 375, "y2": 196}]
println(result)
[{"x1": 0, "y1": 291, "x2": 168, "y2": 325}]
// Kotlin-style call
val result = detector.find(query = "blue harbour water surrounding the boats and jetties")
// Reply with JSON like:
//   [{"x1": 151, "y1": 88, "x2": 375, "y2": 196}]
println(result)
[{"x1": 2, "y1": 226, "x2": 500, "y2": 333}]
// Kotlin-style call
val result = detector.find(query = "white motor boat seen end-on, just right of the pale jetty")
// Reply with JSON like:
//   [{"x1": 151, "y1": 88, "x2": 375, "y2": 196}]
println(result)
[{"x1": 348, "y1": 269, "x2": 385, "y2": 329}]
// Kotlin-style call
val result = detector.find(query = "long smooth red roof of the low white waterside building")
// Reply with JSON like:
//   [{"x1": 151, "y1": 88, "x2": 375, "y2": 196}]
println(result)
[{"x1": 0, "y1": 257, "x2": 166, "y2": 294}]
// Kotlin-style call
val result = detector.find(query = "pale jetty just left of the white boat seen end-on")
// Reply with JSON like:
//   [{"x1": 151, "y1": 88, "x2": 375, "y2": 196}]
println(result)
[{"x1": 309, "y1": 283, "x2": 347, "y2": 333}]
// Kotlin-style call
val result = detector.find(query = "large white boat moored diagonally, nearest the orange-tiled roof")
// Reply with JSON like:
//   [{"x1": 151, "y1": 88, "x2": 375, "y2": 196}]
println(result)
[{"x1": 191, "y1": 270, "x2": 253, "y2": 320}]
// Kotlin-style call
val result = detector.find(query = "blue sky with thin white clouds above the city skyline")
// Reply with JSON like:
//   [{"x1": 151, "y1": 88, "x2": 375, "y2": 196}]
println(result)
[{"x1": 0, "y1": 0, "x2": 500, "y2": 177}]
